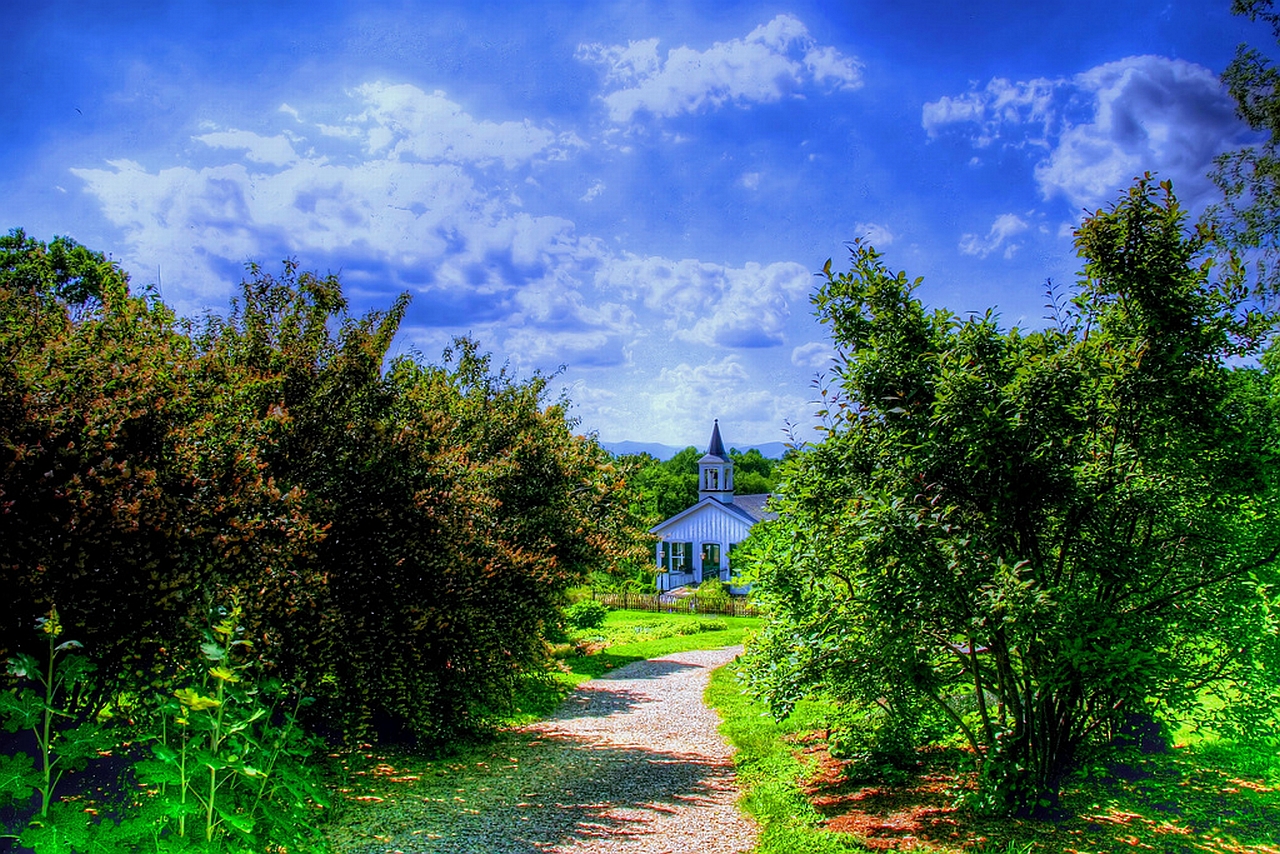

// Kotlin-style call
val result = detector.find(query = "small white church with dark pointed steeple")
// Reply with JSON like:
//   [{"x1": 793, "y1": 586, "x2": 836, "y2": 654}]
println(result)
[{"x1": 649, "y1": 420, "x2": 776, "y2": 593}]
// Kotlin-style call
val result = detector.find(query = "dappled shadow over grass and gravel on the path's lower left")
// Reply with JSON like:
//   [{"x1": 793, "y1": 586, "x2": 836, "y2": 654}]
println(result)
[{"x1": 330, "y1": 734, "x2": 732, "y2": 854}]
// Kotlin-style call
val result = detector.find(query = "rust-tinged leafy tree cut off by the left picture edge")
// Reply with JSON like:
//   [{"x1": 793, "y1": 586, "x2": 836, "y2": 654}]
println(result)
[{"x1": 0, "y1": 230, "x2": 309, "y2": 713}]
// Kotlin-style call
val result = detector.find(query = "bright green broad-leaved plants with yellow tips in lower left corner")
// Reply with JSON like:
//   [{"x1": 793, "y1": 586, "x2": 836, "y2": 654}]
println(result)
[{"x1": 0, "y1": 608, "x2": 326, "y2": 854}]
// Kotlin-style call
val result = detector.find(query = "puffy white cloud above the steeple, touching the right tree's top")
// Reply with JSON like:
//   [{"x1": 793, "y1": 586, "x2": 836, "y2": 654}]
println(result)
[{"x1": 596, "y1": 255, "x2": 813, "y2": 348}]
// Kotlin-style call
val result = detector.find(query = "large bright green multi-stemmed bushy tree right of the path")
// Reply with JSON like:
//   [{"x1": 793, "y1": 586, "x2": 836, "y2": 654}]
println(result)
[{"x1": 746, "y1": 179, "x2": 1280, "y2": 813}]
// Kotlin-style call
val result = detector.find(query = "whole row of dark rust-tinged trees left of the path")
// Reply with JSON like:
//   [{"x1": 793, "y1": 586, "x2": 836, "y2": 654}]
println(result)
[{"x1": 0, "y1": 230, "x2": 648, "y2": 740}]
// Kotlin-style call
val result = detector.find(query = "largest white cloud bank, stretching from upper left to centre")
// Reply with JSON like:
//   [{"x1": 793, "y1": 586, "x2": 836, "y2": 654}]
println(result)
[{"x1": 73, "y1": 78, "x2": 812, "y2": 396}]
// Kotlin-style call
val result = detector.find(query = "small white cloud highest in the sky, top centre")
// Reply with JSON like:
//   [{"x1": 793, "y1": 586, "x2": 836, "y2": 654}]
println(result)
[{"x1": 577, "y1": 15, "x2": 863, "y2": 123}]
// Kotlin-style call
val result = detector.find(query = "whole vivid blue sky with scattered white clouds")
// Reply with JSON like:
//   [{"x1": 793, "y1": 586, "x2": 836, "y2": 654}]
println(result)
[{"x1": 0, "y1": 0, "x2": 1268, "y2": 447}]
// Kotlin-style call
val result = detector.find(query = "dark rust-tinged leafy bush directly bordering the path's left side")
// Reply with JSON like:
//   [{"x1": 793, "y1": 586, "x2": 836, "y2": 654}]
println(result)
[{"x1": 192, "y1": 264, "x2": 650, "y2": 740}]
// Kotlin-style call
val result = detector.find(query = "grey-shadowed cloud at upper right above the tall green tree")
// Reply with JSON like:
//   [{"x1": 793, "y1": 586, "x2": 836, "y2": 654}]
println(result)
[{"x1": 922, "y1": 56, "x2": 1247, "y2": 207}]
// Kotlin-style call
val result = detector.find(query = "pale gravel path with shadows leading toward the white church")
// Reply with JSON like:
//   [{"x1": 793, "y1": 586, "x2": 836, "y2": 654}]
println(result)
[{"x1": 334, "y1": 648, "x2": 756, "y2": 854}]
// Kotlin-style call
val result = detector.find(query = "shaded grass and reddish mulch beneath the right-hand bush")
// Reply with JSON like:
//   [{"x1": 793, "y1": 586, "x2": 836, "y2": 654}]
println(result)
[{"x1": 806, "y1": 745, "x2": 1280, "y2": 854}]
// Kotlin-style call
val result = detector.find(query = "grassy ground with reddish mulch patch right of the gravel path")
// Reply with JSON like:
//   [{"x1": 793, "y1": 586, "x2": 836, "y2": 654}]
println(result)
[{"x1": 707, "y1": 668, "x2": 1280, "y2": 854}]
